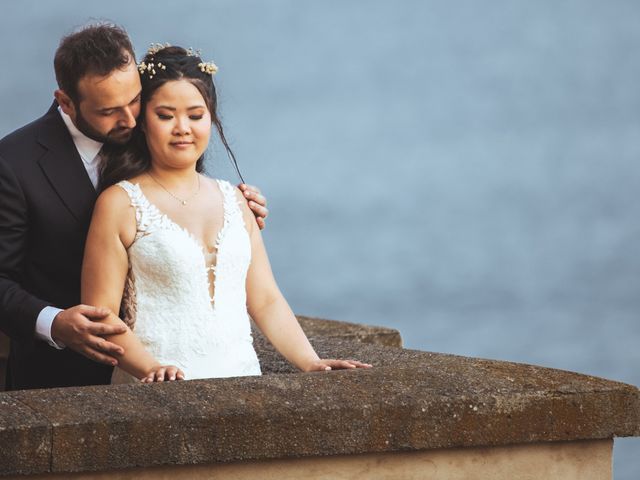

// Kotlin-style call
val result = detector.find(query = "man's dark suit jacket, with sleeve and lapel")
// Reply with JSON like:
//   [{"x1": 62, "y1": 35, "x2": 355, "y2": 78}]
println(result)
[{"x1": 0, "y1": 103, "x2": 111, "y2": 390}]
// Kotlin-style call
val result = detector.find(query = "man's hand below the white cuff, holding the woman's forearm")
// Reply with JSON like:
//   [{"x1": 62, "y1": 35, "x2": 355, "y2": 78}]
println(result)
[{"x1": 51, "y1": 305, "x2": 127, "y2": 366}]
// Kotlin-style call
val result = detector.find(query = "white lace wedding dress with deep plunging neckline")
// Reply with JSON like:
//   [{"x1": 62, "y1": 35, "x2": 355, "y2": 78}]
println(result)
[{"x1": 112, "y1": 176, "x2": 261, "y2": 383}]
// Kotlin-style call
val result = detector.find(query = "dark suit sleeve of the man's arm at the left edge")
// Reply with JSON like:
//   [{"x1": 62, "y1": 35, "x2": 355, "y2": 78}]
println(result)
[{"x1": 0, "y1": 157, "x2": 49, "y2": 342}]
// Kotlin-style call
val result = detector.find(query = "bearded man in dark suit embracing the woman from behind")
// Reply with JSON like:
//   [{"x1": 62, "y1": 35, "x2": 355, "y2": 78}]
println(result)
[{"x1": 0, "y1": 24, "x2": 268, "y2": 390}]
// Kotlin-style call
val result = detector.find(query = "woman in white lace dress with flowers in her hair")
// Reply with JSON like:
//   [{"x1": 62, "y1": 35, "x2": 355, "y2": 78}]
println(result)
[{"x1": 82, "y1": 45, "x2": 371, "y2": 383}]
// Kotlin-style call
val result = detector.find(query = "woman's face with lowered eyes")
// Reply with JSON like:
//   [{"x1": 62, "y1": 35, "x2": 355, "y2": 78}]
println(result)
[{"x1": 143, "y1": 80, "x2": 211, "y2": 168}]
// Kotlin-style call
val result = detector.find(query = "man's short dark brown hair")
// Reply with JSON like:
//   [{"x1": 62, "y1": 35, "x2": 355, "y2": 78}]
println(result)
[{"x1": 53, "y1": 23, "x2": 135, "y2": 103}]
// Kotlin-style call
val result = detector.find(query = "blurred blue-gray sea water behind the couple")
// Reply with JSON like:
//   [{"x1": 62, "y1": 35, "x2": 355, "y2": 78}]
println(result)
[{"x1": 0, "y1": 0, "x2": 640, "y2": 480}]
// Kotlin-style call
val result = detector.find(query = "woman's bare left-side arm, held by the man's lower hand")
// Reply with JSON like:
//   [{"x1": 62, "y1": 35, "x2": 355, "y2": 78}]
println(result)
[{"x1": 81, "y1": 186, "x2": 182, "y2": 378}]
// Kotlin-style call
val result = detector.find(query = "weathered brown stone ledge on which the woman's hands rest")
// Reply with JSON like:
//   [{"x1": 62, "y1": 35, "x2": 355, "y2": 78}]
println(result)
[{"x1": 0, "y1": 326, "x2": 640, "y2": 475}]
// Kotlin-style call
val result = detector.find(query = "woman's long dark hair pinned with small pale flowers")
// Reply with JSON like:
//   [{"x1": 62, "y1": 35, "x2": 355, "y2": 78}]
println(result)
[{"x1": 99, "y1": 46, "x2": 244, "y2": 190}]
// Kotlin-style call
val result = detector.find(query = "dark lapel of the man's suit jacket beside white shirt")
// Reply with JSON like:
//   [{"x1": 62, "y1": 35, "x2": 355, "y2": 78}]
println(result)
[{"x1": 38, "y1": 103, "x2": 96, "y2": 223}]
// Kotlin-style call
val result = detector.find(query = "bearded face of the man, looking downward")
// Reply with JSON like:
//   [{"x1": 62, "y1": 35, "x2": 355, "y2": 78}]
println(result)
[{"x1": 62, "y1": 62, "x2": 141, "y2": 145}]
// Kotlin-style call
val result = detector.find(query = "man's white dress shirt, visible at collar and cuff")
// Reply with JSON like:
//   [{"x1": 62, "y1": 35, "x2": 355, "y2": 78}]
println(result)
[{"x1": 36, "y1": 107, "x2": 102, "y2": 350}]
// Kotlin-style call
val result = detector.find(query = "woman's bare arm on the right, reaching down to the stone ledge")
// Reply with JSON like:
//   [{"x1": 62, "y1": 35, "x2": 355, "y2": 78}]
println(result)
[{"x1": 240, "y1": 189, "x2": 371, "y2": 372}]
